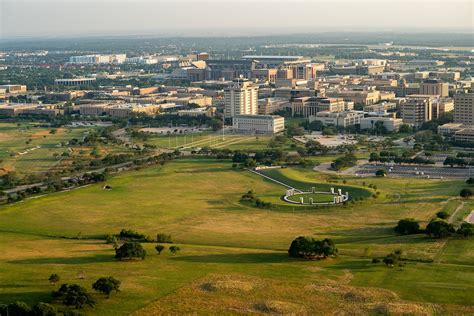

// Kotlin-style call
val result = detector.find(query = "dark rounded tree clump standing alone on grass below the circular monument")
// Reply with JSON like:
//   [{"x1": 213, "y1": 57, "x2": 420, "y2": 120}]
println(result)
[{"x1": 288, "y1": 236, "x2": 337, "y2": 259}]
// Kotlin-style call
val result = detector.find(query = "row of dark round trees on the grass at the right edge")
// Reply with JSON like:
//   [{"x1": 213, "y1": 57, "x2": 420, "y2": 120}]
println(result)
[{"x1": 394, "y1": 218, "x2": 474, "y2": 238}]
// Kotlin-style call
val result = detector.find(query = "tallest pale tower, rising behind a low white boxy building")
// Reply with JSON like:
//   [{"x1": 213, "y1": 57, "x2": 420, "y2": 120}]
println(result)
[{"x1": 224, "y1": 78, "x2": 258, "y2": 118}]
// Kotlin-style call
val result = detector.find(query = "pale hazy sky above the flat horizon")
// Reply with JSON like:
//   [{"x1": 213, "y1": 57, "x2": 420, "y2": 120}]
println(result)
[{"x1": 0, "y1": 0, "x2": 474, "y2": 38}]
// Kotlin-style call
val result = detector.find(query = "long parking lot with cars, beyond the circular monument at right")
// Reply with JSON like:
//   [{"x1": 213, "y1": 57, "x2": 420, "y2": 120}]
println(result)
[{"x1": 355, "y1": 164, "x2": 474, "y2": 179}]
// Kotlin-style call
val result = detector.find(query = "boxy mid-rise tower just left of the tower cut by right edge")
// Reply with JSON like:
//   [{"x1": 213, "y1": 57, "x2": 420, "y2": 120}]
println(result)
[{"x1": 400, "y1": 96, "x2": 432, "y2": 127}]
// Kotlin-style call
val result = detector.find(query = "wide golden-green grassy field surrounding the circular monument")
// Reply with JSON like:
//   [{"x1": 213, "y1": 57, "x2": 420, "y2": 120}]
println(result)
[{"x1": 0, "y1": 159, "x2": 474, "y2": 315}]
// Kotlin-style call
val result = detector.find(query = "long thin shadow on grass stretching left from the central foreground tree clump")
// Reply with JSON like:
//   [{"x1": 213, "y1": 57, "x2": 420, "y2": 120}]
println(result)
[{"x1": 172, "y1": 252, "x2": 292, "y2": 264}]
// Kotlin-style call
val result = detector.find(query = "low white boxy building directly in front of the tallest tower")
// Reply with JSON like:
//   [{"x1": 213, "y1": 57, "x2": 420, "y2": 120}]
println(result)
[{"x1": 233, "y1": 115, "x2": 285, "y2": 134}]
